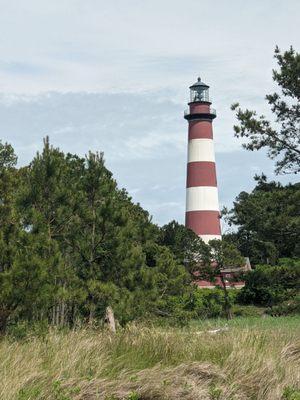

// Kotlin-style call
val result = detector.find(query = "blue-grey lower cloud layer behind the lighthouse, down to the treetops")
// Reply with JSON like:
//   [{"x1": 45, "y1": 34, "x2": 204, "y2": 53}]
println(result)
[{"x1": 0, "y1": 91, "x2": 298, "y2": 228}]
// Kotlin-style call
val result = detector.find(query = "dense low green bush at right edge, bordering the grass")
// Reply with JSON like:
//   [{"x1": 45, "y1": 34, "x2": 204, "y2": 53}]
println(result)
[{"x1": 238, "y1": 259, "x2": 300, "y2": 309}]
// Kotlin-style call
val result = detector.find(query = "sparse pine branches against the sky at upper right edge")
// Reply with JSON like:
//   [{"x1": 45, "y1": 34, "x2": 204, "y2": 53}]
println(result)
[{"x1": 231, "y1": 47, "x2": 300, "y2": 174}]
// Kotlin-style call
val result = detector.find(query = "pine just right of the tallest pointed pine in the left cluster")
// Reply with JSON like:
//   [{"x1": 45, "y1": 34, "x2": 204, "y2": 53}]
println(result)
[{"x1": 62, "y1": 152, "x2": 118, "y2": 322}]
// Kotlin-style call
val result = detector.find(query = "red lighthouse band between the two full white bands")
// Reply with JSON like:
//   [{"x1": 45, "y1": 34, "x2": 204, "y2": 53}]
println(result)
[{"x1": 186, "y1": 161, "x2": 217, "y2": 187}]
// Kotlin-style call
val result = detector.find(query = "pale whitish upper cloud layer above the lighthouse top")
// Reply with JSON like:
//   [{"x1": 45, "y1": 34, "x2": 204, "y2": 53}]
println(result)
[{"x1": 0, "y1": 0, "x2": 300, "y2": 93}]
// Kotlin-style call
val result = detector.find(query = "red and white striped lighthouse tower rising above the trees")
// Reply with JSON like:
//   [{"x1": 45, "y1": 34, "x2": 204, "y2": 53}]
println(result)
[{"x1": 184, "y1": 78, "x2": 221, "y2": 243}]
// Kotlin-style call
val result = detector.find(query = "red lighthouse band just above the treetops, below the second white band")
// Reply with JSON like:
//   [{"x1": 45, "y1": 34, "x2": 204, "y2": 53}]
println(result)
[{"x1": 185, "y1": 211, "x2": 221, "y2": 235}]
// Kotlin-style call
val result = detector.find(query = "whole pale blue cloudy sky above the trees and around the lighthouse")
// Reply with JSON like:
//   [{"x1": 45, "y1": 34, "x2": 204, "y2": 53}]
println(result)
[{"x1": 0, "y1": 0, "x2": 300, "y2": 230}]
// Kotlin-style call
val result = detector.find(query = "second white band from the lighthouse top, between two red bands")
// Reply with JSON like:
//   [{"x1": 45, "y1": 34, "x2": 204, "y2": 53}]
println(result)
[{"x1": 186, "y1": 186, "x2": 219, "y2": 211}]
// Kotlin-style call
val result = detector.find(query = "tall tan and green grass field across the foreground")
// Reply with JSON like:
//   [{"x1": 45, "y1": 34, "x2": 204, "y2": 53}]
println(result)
[{"x1": 0, "y1": 317, "x2": 300, "y2": 400}]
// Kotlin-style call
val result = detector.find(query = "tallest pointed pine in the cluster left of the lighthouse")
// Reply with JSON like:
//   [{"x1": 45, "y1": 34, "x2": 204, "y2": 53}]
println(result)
[{"x1": 12, "y1": 138, "x2": 83, "y2": 325}]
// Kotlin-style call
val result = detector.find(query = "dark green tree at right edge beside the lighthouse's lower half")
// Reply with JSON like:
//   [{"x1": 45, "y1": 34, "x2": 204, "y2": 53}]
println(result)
[{"x1": 224, "y1": 175, "x2": 300, "y2": 265}]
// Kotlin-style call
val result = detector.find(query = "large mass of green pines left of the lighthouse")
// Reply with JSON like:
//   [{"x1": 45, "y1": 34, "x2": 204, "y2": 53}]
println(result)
[{"x1": 0, "y1": 138, "x2": 190, "y2": 330}]
